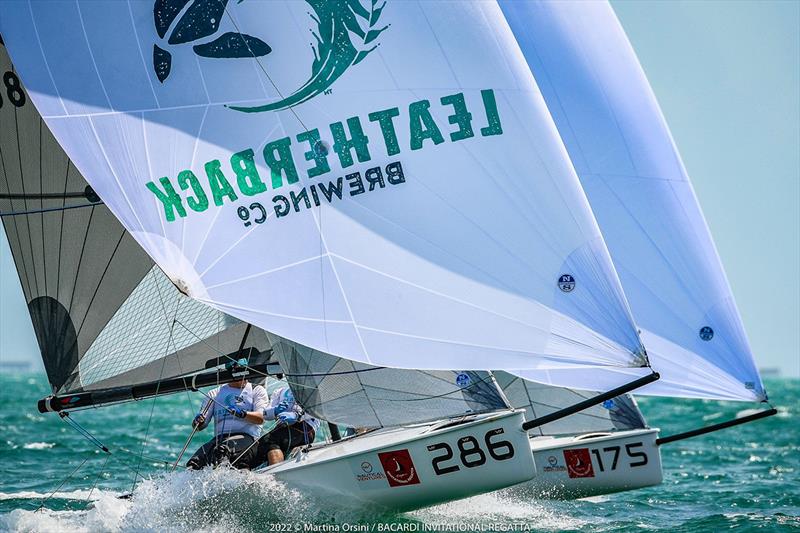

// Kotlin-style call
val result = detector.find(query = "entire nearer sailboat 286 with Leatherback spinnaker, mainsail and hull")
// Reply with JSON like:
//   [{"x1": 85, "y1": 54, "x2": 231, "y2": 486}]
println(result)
[{"x1": 0, "y1": 0, "x2": 657, "y2": 510}]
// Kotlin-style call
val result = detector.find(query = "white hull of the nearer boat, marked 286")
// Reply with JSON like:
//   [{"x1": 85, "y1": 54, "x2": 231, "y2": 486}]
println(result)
[{"x1": 260, "y1": 410, "x2": 535, "y2": 511}]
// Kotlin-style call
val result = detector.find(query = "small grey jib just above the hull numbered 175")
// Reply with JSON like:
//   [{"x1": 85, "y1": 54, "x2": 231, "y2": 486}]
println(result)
[{"x1": 494, "y1": 371, "x2": 647, "y2": 435}]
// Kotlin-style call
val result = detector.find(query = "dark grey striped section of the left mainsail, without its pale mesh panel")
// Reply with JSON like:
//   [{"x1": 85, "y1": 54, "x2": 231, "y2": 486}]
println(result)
[{"x1": 0, "y1": 40, "x2": 153, "y2": 392}]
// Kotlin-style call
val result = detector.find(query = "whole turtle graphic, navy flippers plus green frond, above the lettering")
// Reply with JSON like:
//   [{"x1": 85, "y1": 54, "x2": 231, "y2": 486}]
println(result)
[{"x1": 153, "y1": 0, "x2": 389, "y2": 113}]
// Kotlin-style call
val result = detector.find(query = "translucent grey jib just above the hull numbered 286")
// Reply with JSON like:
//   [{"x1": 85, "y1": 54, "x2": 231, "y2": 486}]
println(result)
[{"x1": 266, "y1": 332, "x2": 507, "y2": 427}]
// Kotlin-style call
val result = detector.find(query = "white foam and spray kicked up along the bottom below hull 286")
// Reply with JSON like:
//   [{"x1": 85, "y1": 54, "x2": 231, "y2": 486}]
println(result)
[{"x1": 0, "y1": 468, "x2": 587, "y2": 533}]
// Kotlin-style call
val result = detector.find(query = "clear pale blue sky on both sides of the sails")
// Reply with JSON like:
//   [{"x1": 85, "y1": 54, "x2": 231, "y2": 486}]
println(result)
[{"x1": 0, "y1": 0, "x2": 800, "y2": 377}]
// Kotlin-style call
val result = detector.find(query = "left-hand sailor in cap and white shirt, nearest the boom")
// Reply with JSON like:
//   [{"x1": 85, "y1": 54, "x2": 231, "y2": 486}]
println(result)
[{"x1": 186, "y1": 359, "x2": 269, "y2": 470}]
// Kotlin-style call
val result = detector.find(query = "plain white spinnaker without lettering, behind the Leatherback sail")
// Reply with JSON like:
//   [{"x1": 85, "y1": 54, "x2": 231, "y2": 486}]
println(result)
[{"x1": 501, "y1": 1, "x2": 766, "y2": 400}]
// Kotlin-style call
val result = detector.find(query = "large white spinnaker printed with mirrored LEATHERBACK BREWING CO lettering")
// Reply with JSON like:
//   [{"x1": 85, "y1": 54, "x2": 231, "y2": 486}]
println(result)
[{"x1": 0, "y1": 0, "x2": 645, "y2": 374}]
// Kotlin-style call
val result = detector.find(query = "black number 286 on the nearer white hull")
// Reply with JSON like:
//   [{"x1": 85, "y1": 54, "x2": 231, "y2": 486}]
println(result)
[{"x1": 428, "y1": 428, "x2": 514, "y2": 476}]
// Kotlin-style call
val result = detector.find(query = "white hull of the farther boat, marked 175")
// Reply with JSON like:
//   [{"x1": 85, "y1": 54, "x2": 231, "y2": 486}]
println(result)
[{"x1": 510, "y1": 429, "x2": 663, "y2": 499}]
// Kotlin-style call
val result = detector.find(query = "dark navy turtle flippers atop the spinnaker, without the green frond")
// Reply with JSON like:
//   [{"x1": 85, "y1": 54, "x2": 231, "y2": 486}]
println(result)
[{"x1": 153, "y1": 0, "x2": 272, "y2": 83}]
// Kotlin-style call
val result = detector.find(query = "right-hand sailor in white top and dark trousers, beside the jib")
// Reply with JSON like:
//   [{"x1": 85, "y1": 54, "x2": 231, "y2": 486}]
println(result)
[{"x1": 253, "y1": 387, "x2": 319, "y2": 465}]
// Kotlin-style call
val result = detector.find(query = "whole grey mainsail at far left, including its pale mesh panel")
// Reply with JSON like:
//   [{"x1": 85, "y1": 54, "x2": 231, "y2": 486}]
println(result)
[{"x1": 0, "y1": 44, "x2": 260, "y2": 394}]
